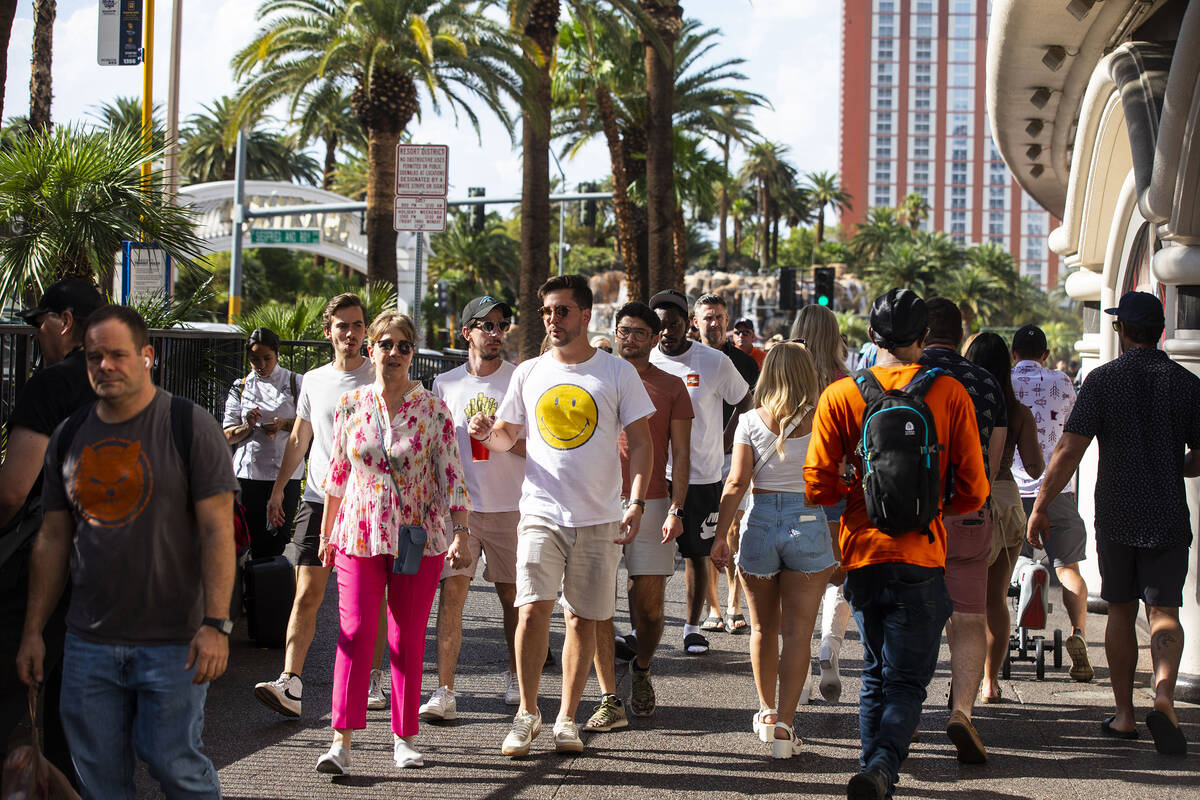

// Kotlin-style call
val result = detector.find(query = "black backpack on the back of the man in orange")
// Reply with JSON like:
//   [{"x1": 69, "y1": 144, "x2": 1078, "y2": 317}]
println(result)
[{"x1": 853, "y1": 368, "x2": 947, "y2": 542}]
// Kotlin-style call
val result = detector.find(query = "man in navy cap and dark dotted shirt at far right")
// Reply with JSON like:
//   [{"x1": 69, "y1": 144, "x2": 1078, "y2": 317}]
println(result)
[{"x1": 1028, "y1": 291, "x2": 1200, "y2": 756}]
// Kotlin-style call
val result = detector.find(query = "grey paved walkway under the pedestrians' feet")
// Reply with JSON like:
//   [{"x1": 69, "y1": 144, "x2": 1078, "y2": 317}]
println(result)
[{"x1": 139, "y1": 571, "x2": 1200, "y2": 800}]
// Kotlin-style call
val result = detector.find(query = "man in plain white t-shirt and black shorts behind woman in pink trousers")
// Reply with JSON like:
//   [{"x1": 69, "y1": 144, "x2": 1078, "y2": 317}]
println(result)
[{"x1": 254, "y1": 294, "x2": 376, "y2": 717}]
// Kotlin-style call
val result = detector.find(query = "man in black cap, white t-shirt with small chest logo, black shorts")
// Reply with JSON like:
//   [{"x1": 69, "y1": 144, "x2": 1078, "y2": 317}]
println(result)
[{"x1": 650, "y1": 289, "x2": 754, "y2": 655}]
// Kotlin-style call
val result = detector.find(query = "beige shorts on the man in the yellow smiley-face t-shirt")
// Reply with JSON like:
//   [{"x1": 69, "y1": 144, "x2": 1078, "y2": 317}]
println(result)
[{"x1": 514, "y1": 516, "x2": 620, "y2": 620}]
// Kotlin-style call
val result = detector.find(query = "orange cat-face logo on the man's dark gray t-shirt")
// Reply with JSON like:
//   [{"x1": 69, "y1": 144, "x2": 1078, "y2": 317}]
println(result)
[{"x1": 74, "y1": 439, "x2": 154, "y2": 528}]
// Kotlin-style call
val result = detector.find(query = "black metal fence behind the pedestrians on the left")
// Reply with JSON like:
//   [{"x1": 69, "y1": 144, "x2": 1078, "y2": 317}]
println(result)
[{"x1": 0, "y1": 325, "x2": 466, "y2": 423}]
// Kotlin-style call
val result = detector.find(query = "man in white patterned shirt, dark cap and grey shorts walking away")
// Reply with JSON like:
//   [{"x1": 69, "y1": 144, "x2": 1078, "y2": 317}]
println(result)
[{"x1": 1013, "y1": 325, "x2": 1096, "y2": 684}]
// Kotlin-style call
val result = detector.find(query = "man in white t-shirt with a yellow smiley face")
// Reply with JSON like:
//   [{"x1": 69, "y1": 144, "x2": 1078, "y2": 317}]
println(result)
[{"x1": 469, "y1": 275, "x2": 654, "y2": 756}]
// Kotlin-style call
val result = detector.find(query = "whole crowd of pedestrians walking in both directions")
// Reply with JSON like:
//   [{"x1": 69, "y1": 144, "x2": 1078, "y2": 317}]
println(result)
[{"x1": 0, "y1": 276, "x2": 1200, "y2": 799}]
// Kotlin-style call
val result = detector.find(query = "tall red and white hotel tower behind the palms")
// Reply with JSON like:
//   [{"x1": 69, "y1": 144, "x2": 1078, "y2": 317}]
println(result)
[{"x1": 841, "y1": 0, "x2": 1058, "y2": 289}]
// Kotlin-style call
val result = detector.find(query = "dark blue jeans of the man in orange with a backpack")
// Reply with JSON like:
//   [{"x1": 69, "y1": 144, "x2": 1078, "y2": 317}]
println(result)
[{"x1": 845, "y1": 564, "x2": 953, "y2": 796}]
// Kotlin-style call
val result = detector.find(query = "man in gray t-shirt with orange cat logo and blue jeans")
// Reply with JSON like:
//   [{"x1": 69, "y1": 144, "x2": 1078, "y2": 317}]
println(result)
[{"x1": 17, "y1": 306, "x2": 238, "y2": 798}]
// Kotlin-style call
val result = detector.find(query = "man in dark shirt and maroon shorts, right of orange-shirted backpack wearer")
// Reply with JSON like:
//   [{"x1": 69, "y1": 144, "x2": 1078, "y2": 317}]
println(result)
[{"x1": 920, "y1": 297, "x2": 1008, "y2": 764}]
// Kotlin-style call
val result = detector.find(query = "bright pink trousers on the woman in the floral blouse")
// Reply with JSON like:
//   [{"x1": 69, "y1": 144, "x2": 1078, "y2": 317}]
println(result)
[{"x1": 331, "y1": 551, "x2": 445, "y2": 736}]
